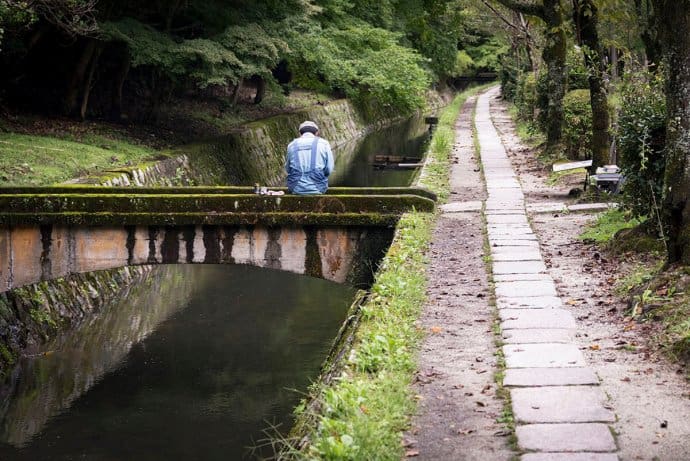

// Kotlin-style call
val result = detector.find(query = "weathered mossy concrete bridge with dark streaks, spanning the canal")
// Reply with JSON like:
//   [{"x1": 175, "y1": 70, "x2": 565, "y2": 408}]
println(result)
[{"x1": 0, "y1": 186, "x2": 435, "y2": 292}]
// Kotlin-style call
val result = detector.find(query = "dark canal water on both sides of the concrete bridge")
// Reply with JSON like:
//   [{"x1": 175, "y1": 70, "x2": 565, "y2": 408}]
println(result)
[{"x1": 0, "y1": 113, "x2": 427, "y2": 461}]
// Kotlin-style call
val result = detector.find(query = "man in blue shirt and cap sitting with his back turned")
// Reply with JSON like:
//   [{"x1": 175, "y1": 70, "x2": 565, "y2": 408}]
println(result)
[{"x1": 285, "y1": 120, "x2": 334, "y2": 195}]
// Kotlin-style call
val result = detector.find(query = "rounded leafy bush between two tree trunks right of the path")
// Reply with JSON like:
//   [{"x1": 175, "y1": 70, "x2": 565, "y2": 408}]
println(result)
[{"x1": 563, "y1": 90, "x2": 592, "y2": 160}]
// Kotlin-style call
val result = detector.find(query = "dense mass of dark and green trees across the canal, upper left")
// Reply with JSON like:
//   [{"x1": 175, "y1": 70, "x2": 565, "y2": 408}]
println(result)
[{"x1": 0, "y1": 0, "x2": 505, "y2": 121}]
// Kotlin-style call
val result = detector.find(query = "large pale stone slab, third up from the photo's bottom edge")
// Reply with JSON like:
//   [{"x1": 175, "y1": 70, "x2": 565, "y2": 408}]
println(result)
[{"x1": 510, "y1": 386, "x2": 616, "y2": 424}]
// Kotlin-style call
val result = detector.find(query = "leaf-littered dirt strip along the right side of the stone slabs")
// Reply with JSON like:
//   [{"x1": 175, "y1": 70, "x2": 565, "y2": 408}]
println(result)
[{"x1": 491, "y1": 92, "x2": 690, "y2": 460}]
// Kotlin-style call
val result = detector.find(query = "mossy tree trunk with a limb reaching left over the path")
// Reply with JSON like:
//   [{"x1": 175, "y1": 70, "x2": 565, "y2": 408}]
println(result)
[{"x1": 498, "y1": 0, "x2": 567, "y2": 150}]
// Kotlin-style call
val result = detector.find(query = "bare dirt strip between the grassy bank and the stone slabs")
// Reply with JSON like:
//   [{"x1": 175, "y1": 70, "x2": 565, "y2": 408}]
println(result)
[{"x1": 406, "y1": 99, "x2": 512, "y2": 460}]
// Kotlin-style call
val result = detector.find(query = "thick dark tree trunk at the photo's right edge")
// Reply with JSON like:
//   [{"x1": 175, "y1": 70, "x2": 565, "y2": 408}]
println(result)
[{"x1": 654, "y1": 0, "x2": 690, "y2": 265}]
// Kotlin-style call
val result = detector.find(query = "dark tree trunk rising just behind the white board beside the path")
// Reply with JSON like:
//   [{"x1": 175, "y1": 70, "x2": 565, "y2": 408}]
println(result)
[{"x1": 573, "y1": 0, "x2": 611, "y2": 172}]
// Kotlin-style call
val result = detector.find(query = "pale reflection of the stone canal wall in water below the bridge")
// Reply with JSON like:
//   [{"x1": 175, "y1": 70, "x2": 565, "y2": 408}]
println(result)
[{"x1": 0, "y1": 266, "x2": 193, "y2": 447}]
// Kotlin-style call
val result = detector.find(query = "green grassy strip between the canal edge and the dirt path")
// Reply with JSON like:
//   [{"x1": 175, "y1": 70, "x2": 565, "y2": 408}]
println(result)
[{"x1": 284, "y1": 85, "x2": 490, "y2": 460}]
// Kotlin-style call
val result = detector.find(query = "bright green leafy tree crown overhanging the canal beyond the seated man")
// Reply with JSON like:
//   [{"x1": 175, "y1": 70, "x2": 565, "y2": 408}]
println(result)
[{"x1": 290, "y1": 24, "x2": 430, "y2": 113}]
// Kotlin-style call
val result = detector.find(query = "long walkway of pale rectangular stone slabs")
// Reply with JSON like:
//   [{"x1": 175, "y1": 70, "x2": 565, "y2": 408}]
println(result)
[{"x1": 475, "y1": 90, "x2": 618, "y2": 461}]
